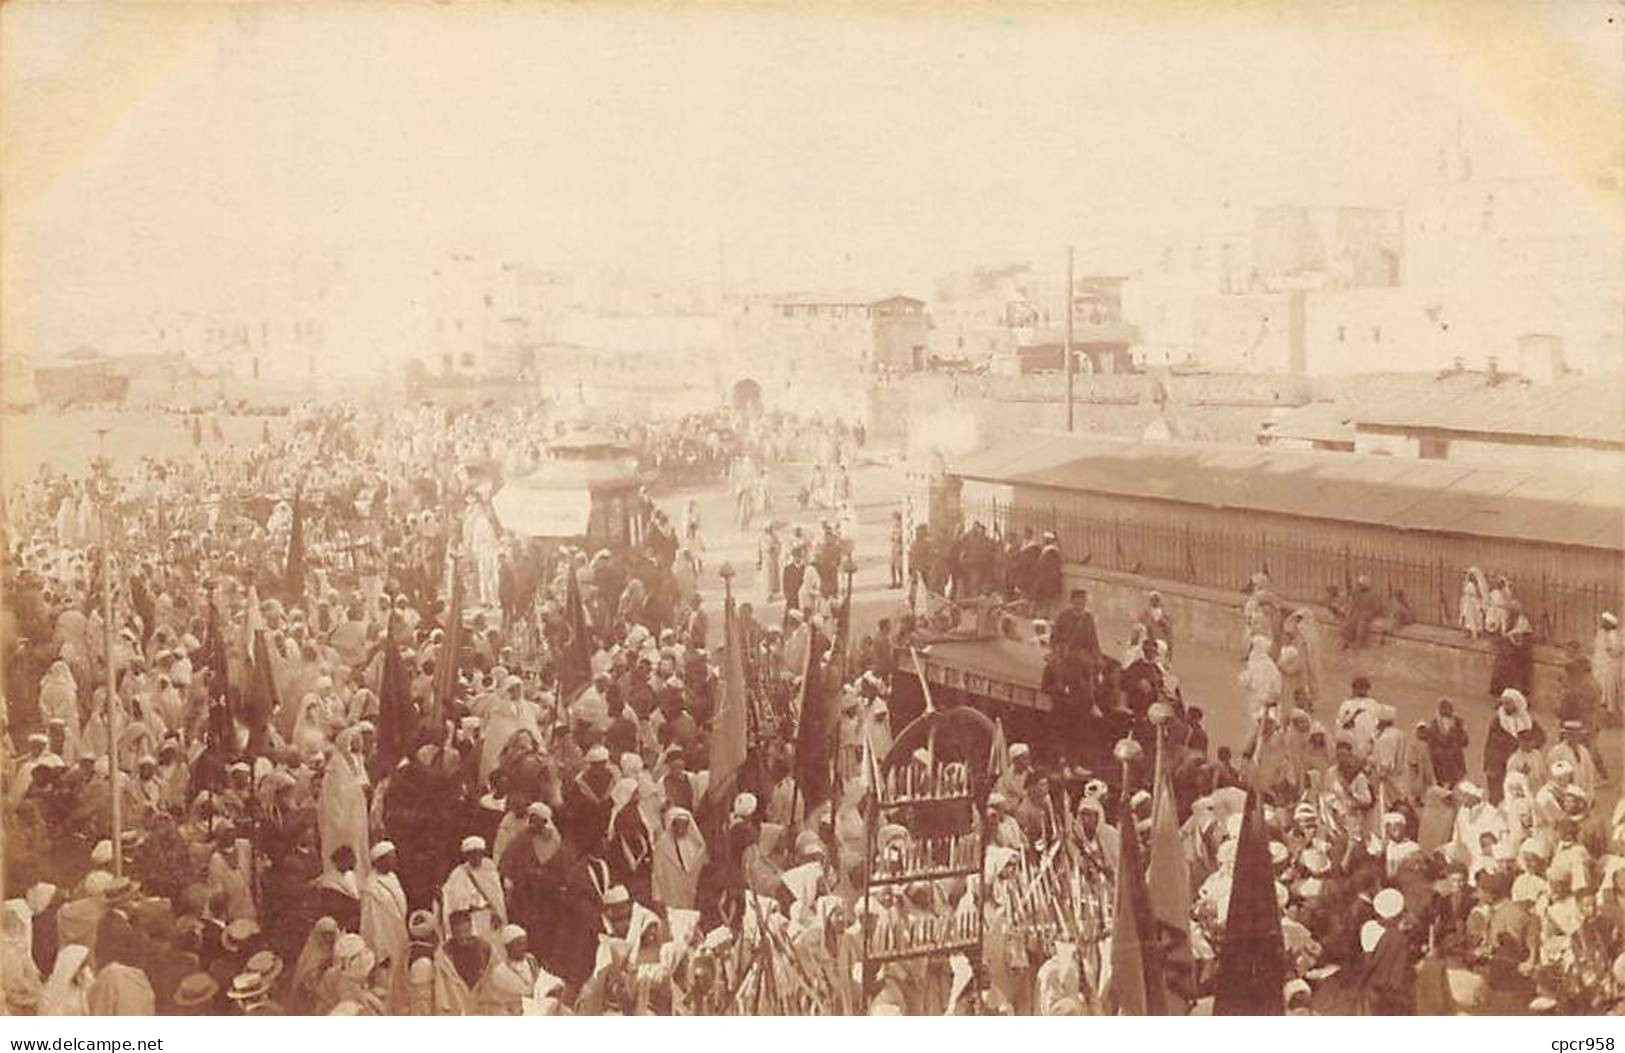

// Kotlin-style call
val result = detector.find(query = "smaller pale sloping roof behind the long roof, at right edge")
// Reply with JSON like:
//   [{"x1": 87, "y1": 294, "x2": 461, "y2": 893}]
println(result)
[{"x1": 1355, "y1": 375, "x2": 1625, "y2": 444}]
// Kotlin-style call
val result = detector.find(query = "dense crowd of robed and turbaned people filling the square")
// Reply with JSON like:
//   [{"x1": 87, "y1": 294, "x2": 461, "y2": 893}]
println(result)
[{"x1": 0, "y1": 399, "x2": 1625, "y2": 1016}]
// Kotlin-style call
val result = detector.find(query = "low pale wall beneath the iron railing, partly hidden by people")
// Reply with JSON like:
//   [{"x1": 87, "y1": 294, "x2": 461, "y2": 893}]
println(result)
[{"x1": 1064, "y1": 564, "x2": 1563, "y2": 713}]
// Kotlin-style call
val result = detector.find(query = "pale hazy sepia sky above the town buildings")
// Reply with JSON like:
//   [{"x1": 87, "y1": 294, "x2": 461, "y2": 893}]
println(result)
[{"x1": 0, "y1": 0, "x2": 1622, "y2": 354}]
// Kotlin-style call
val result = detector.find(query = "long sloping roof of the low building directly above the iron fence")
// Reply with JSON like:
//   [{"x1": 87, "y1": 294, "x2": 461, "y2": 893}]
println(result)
[{"x1": 952, "y1": 432, "x2": 1625, "y2": 549}]
